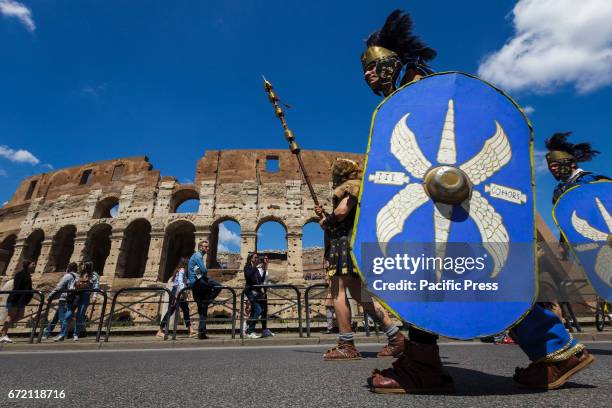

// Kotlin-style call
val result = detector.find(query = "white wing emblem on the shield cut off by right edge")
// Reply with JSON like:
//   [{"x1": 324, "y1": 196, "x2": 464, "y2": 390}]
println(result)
[{"x1": 572, "y1": 197, "x2": 612, "y2": 285}]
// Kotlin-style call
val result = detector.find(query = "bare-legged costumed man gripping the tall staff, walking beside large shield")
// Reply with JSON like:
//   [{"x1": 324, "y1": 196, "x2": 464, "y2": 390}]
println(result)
[{"x1": 315, "y1": 159, "x2": 405, "y2": 361}]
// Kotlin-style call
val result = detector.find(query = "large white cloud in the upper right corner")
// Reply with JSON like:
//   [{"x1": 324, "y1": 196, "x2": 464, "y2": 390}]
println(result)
[{"x1": 478, "y1": 0, "x2": 612, "y2": 93}]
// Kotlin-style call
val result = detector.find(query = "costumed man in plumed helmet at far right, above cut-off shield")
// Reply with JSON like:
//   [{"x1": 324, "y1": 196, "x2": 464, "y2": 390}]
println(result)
[{"x1": 546, "y1": 132, "x2": 609, "y2": 204}]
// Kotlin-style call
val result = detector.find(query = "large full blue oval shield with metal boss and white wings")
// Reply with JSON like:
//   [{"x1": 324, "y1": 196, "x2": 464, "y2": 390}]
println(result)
[{"x1": 352, "y1": 72, "x2": 536, "y2": 339}]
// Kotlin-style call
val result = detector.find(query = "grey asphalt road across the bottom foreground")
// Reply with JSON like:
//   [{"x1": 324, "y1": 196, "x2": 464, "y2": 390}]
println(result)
[{"x1": 0, "y1": 342, "x2": 612, "y2": 408}]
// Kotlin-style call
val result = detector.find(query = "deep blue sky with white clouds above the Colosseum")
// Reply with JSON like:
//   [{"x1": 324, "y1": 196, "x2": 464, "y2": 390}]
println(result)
[{"x1": 0, "y1": 0, "x2": 612, "y2": 252}]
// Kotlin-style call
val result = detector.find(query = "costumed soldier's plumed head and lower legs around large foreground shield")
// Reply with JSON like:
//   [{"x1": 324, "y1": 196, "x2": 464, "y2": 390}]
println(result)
[{"x1": 361, "y1": 10, "x2": 593, "y2": 393}]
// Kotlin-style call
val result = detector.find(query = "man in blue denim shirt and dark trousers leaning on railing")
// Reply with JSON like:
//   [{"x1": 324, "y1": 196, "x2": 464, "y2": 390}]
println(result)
[{"x1": 187, "y1": 241, "x2": 221, "y2": 340}]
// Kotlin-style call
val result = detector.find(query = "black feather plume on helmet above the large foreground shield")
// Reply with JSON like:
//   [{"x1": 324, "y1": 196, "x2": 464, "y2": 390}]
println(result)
[{"x1": 366, "y1": 9, "x2": 437, "y2": 72}]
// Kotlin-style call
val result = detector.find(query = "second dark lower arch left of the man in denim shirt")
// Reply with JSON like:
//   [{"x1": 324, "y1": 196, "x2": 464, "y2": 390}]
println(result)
[{"x1": 115, "y1": 218, "x2": 151, "y2": 278}]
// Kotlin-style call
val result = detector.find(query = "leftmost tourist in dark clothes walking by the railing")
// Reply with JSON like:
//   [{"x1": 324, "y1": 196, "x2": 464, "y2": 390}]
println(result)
[{"x1": 0, "y1": 260, "x2": 36, "y2": 343}]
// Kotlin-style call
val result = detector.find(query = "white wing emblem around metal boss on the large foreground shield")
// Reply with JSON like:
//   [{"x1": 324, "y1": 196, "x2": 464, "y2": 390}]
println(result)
[{"x1": 376, "y1": 99, "x2": 512, "y2": 279}]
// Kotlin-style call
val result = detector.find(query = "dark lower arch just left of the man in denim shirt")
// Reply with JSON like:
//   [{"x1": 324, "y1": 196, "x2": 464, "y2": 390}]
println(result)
[{"x1": 158, "y1": 220, "x2": 196, "y2": 282}]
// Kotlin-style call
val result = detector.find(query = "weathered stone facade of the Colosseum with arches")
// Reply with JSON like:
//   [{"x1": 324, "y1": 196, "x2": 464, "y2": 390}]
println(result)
[{"x1": 0, "y1": 150, "x2": 362, "y2": 289}]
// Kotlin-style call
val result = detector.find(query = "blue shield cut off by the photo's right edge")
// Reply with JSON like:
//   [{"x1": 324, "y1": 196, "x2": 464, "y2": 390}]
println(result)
[{"x1": 553, "y1": 181, "x2": 612, "y2": 302}]
